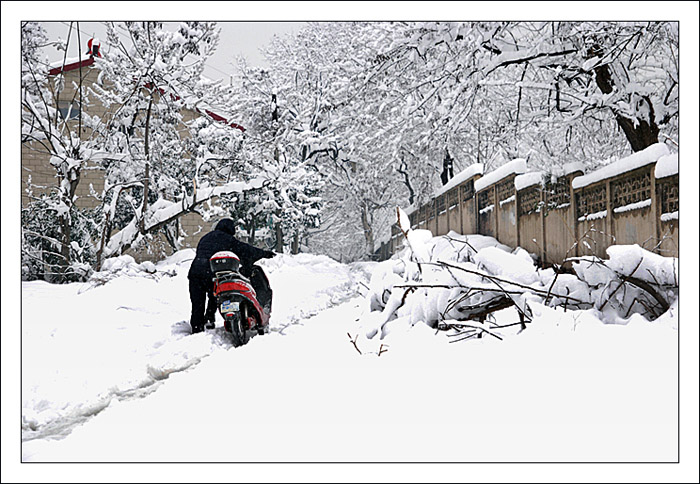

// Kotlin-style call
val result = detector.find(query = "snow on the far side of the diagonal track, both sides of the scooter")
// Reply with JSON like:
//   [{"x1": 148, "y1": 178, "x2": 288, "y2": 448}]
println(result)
[{"x1": 22, "y1": 251, "x2": 372, "y2": 454}]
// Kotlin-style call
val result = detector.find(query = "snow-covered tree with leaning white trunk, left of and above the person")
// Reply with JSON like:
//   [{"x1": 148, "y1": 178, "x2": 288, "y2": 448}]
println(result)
[{"x1": 87, "y1": 22, "x2": 262, "y2": 264}]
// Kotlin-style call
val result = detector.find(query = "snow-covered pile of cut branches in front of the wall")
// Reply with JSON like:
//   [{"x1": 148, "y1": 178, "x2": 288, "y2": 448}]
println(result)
[{"x1": 363, "y1": 208, "x2": 678, "y2": 339}]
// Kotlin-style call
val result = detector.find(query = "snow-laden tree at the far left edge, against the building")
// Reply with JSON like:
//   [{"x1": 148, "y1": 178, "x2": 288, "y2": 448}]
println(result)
[{"x1": 21, "y1": 22, "x2": 100, "y2": 281}]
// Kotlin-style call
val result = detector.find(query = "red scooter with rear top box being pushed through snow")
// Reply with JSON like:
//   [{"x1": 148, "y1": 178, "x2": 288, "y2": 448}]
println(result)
[{"x1": 209, "y1": 251, "x2": 270, "y2": 347}]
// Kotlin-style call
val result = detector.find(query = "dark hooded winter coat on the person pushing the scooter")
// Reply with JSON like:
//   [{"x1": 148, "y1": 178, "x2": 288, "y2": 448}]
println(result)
[{"x1": 187, "y1": 218, "x2": 275, "y2": 280}]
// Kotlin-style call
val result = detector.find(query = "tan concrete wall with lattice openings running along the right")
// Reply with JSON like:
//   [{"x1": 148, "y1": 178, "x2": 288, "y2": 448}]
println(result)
[{"x1": 380, "y1": 156, "x2": 679, "y2": 265}]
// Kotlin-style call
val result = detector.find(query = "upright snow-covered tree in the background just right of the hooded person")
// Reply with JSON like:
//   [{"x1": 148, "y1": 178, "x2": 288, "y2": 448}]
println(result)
[{"x1": 231, "y1": 31, "x2": 337, "y2": 252}]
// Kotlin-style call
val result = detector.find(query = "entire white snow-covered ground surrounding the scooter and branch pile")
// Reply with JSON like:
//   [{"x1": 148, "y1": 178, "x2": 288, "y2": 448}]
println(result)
[{"x1": 17, "y1": 242, "x2": 678, "y2": 462}]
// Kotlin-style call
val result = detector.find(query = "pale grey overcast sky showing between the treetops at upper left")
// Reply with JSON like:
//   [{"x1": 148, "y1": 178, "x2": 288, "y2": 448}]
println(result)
[{"x1": 42, "y1": 21, "x2": 304, "y2": 81}]
